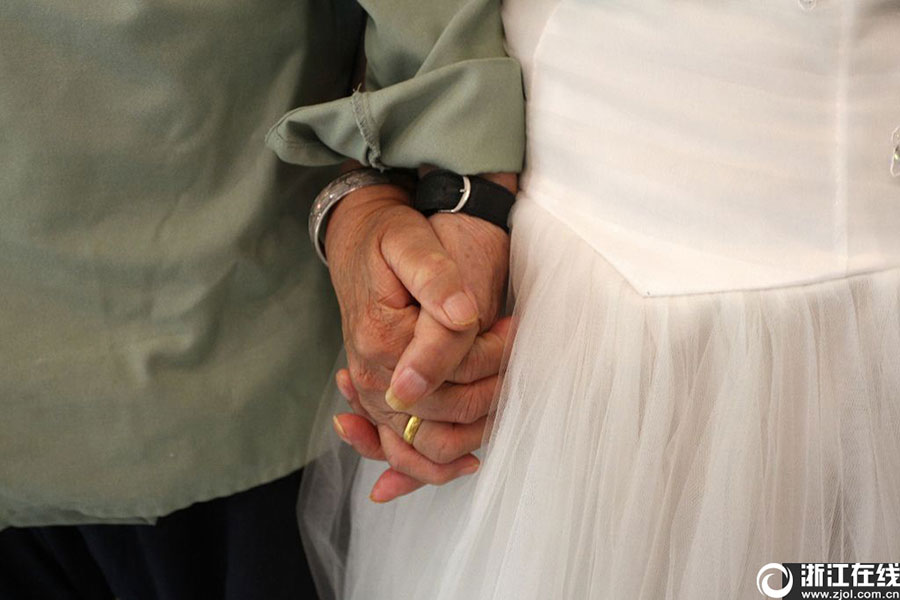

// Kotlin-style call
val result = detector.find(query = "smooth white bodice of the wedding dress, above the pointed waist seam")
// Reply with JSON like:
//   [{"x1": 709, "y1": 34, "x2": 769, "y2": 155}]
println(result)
[{"x1": 504, "y1": 0, "x2": 900, "y2": 296}]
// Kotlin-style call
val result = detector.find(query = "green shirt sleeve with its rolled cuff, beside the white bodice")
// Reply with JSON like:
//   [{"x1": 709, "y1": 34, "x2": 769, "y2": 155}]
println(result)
[{"x1": 267, "y1": 0, "x2": 525, "y2": 173}]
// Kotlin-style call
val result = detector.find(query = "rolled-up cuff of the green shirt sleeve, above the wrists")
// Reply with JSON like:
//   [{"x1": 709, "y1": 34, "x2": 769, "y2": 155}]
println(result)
[{"x1": 266, "y1": 58, "x2": 525, "y2": 173}]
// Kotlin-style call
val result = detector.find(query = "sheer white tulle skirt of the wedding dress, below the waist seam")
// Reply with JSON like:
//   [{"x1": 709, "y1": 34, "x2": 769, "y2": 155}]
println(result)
[{"x1": 299, "y1": 201, "x2": 900, "y2": 600}]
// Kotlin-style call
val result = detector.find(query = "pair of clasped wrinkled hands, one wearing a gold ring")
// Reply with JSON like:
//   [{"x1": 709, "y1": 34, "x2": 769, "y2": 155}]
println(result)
[{"x1": 325, "y1": 174, "x2": 516, "y2": 502}]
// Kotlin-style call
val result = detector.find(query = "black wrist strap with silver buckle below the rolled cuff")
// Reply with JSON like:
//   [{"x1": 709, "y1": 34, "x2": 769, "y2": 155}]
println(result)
[{"x1": 413, "y1": 169, "x2": 516, "y2": 233}]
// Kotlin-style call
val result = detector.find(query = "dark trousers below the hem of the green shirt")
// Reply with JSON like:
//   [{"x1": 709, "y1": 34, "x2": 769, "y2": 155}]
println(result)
[{"x1": 0, "y1": 471, "x2": 316, "y2": 600}]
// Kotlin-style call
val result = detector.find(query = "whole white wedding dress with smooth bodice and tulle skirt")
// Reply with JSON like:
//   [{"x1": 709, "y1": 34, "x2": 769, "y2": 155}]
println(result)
[{"x1": 301, "y1": 0, "x2": 900, "y2": 600}]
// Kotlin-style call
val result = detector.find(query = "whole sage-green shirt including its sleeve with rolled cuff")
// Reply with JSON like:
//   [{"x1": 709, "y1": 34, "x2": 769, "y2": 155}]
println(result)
[{"x1": 0, "y1": 0, "x2": 524, "y2": 528}]
